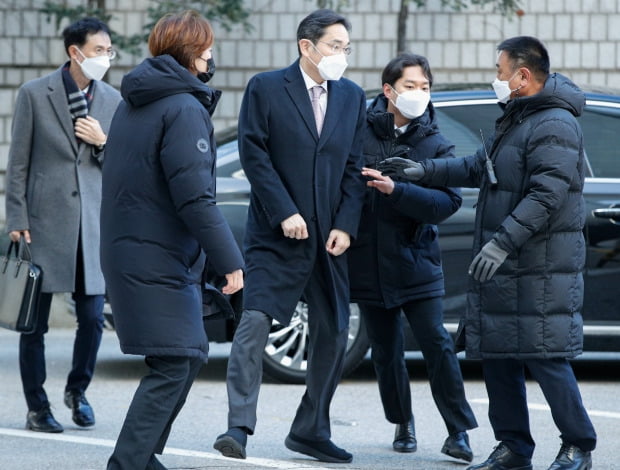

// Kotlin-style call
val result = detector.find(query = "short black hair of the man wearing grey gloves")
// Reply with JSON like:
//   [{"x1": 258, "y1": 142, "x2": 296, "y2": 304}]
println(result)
[{"x1": 497, "y1": 36, "x2": 549, "y2": 82}]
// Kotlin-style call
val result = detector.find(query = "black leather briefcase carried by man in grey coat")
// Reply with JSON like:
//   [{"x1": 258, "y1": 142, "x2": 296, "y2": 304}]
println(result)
[{"x1": 0, "y1": 237, "x2": 43, "y2": 333}]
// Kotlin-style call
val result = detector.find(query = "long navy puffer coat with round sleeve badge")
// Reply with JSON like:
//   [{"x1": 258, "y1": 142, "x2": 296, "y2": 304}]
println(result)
[{"x1": 101, "y1": 55, "x2": 243, "y2": 357}]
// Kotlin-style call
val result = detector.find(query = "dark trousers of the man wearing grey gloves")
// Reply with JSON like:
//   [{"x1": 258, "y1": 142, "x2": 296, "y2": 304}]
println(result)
[{"x1": 482, "y1": 358, "x2": 596, "y2": 457}]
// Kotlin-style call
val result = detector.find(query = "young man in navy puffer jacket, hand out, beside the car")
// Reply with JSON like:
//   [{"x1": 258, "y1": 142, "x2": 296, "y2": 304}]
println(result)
[{"x1": 349, "y1": 54, "x2": 477, "y2": 461}]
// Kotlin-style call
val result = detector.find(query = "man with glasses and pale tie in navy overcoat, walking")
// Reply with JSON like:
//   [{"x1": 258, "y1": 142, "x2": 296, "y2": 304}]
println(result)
[{"x1": 214, "y1": 10, "x2": 366, "y2": 463}]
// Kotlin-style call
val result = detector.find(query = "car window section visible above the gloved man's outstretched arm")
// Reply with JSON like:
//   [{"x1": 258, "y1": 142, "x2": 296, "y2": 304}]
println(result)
[{"x1": 435, "y1": 103, "x2": 502, "y2": 157}]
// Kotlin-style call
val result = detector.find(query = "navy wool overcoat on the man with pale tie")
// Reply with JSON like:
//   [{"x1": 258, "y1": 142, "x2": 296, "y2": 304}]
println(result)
[{"x1": 239, "y1": 61, "x2": 366, "y2": 330}]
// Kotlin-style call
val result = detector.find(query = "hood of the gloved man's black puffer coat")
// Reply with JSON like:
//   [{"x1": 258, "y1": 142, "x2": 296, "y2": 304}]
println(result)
[{"x1": 505, "y1": 73, "x2": 586, "y2": 116}]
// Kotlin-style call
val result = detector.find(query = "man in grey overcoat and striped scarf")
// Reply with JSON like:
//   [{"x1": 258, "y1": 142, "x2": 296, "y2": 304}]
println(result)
[{"x1": 6, "y1": 18, "x2": 121, "y2": 433}]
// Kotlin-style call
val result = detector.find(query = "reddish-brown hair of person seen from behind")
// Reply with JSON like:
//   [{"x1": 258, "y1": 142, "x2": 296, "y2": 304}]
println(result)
[{"x1": 149, "y1": 10, "x2": 215, "y2": 71}]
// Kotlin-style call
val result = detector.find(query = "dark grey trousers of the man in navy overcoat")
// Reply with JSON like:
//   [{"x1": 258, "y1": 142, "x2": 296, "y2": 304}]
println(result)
[{"x1": 226, "y1": 260, "x2": 348, "y2": 441}]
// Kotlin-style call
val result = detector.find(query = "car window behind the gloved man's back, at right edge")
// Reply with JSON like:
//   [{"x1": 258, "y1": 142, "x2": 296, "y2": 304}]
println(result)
[{"x1": 579, "y1": 104, "x2": 620, "y2": 178}]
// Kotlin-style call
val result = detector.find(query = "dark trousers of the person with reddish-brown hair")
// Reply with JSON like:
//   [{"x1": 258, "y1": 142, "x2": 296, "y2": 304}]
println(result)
[{"x1": 107, "y1": 356, "x2": 203, "y2": 470}]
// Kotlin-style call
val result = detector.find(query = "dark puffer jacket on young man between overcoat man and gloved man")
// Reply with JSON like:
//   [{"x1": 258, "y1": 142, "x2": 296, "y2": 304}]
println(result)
[{"x1": 348, "y1": 94, "x2": 461, "y2": 308}]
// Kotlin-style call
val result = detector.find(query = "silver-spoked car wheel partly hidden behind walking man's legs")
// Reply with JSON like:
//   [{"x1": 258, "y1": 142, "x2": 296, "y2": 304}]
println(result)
[{"x1": 263, "y1": 301, "x2": 369, "y2": 384}]
